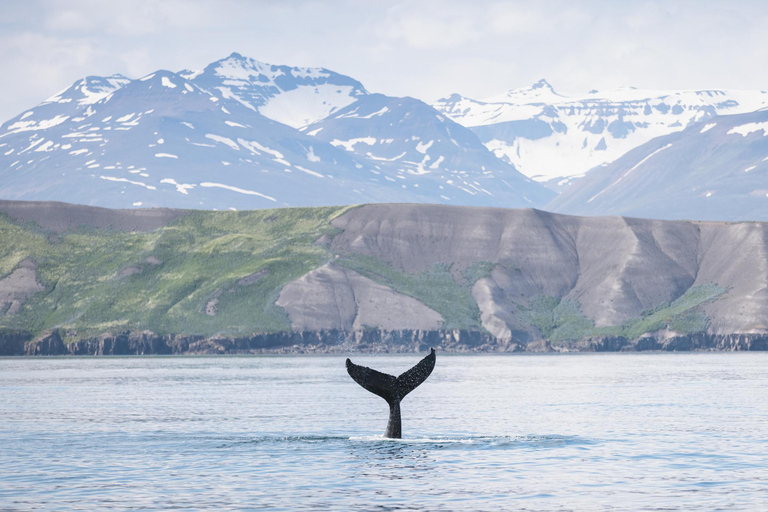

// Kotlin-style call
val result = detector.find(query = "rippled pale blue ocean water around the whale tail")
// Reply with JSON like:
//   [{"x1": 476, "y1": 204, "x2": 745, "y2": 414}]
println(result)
[{"x1": 0, "y1": 353, "x2": 768, "y2": 511}]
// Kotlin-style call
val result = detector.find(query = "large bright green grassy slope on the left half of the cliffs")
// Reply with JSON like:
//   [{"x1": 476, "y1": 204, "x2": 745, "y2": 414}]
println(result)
[{"x1": 0, "y1": 208, "x2": 346, "y2": 336}]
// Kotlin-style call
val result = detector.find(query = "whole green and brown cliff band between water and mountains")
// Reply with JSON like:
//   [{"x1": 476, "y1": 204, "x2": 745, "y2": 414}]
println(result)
[{"x1": 0, "y1": 202, "x2": 768, "y2": 355}]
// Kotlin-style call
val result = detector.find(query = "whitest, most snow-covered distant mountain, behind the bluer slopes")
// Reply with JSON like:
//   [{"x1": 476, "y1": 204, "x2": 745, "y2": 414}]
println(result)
[{"x1": 433, "y1": 80, "x2": 768, "y2": 188}]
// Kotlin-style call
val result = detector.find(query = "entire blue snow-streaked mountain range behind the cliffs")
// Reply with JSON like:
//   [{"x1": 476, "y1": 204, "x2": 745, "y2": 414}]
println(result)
[{"x1": 0, "y1": 53, "x2": 768, "y2": 220}]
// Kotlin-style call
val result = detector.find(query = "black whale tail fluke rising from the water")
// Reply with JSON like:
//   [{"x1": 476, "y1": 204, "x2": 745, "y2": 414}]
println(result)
[{"x1": 347, "y1": 348, "x2": 436, "y2": 439}]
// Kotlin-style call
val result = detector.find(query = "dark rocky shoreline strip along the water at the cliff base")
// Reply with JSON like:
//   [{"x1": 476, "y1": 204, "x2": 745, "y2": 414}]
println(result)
[{"x1": 0, "y1": 330, "x2": 768, "y2": 356}]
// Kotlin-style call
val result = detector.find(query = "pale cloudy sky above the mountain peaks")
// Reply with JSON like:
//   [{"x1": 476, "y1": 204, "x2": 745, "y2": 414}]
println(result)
[{"x1": 0, "y1": 0, "x2": 768, "y2": 122}]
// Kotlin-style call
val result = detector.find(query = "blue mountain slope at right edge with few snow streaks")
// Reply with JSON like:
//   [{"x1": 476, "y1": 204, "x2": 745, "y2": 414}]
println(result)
[{"x1": 546, "y1": 109, "x2": 768, "y2": 221}]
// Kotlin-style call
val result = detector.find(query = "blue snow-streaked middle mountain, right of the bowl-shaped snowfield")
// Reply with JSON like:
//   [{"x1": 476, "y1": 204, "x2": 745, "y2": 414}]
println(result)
[{"x1": 304, "y1": 94, "x2": 551, "y2": 206}]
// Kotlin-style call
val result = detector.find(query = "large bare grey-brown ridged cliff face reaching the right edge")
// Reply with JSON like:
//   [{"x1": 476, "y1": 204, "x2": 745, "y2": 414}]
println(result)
[{"x1": 331, "y1": 204, "x2": 768, "y2": 339}]
